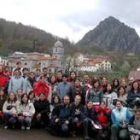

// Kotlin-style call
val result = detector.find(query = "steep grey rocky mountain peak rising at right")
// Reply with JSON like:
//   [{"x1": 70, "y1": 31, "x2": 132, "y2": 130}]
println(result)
[{"x1": 77, "y1": 16, "x2": 140, "y2": 53}]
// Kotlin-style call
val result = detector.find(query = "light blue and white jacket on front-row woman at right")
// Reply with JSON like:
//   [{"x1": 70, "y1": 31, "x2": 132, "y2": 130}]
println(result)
[{"x1": 111, "y1": 107, "x2": 131, "y2": 127}]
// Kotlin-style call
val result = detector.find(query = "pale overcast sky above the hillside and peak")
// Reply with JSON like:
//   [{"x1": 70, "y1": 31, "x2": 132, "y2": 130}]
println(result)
[{"x1": 0, "y1": 0, "x2": 140, "y2": 42}]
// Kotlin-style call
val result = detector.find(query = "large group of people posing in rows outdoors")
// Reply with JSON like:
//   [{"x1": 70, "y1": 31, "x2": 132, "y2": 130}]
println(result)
[{"x1": 0, "y1": 62, "x2": 140, "y2": 140}]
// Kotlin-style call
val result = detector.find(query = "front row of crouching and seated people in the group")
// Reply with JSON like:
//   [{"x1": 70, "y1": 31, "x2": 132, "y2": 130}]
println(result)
[{"x1": 1, "y1": 93, "x2": 140, "y2": 140}]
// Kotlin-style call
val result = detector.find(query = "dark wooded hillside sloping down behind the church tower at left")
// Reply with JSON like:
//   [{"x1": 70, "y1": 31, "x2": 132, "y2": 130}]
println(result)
[{"x1": 0, "y1": 19, "x2": 72, "y2": 55}]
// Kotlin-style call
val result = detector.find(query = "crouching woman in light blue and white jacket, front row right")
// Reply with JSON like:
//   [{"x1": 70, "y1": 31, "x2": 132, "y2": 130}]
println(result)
[{"x1": 110, "y1": 100, "x2": 131, "y2": 140}]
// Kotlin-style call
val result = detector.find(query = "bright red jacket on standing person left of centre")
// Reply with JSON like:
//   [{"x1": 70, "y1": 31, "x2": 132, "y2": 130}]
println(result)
[{"x1": 33, "y1": 80, "x2": 49, "y2": 98}]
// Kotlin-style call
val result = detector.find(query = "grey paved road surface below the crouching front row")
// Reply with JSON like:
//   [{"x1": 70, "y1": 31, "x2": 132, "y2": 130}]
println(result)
[{"x1": 0, "y1": 126, "x2": 83, "y2": 140}]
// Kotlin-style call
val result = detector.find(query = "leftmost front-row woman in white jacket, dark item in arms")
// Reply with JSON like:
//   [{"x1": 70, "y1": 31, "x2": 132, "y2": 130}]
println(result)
[{"x1": 3, "y1": 93, "x2": 19, "y2": 129}]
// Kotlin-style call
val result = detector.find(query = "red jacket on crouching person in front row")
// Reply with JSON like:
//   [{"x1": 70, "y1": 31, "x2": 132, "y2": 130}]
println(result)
[{"x1": 95, "y1": 106, "x2": 110, "y2": 127}]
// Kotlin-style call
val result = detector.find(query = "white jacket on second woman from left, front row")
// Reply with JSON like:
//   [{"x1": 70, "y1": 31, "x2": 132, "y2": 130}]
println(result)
[{"x1": 19, "y1": 102, "x2": 35, "y2": 117}]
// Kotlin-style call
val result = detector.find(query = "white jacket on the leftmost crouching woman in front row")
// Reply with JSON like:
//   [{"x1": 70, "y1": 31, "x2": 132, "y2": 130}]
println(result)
[{"x1": 2, "y1": 101, "x2": 19, "y2": 114}]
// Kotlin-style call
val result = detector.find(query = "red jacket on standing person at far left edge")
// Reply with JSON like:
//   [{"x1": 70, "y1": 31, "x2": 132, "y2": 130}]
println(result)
[{"x1": 0, "y1": 72, "x2": 10, "y2": 88}]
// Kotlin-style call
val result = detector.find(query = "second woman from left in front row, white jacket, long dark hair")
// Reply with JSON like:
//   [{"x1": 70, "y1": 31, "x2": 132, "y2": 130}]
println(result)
[{"x1": 18, "y1": 94, "x2": 35, "y2": 130}]
